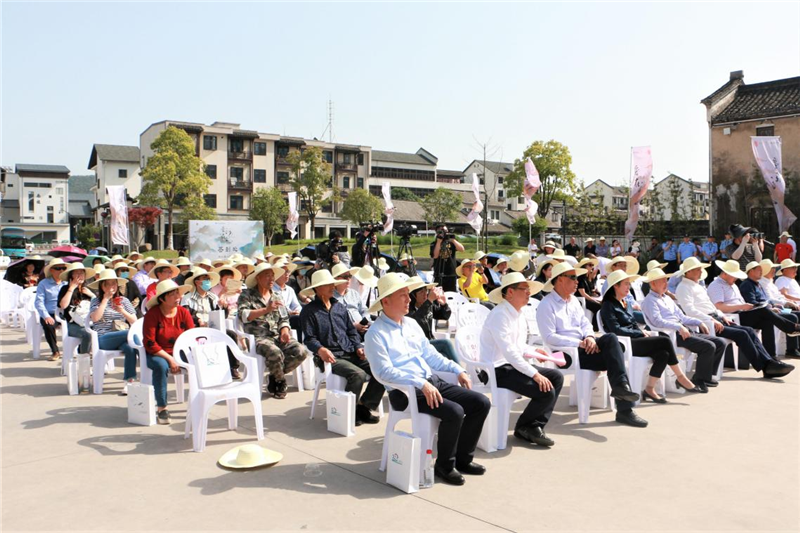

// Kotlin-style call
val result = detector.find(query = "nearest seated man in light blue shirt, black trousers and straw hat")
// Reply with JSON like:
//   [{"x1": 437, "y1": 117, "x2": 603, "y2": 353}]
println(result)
[{"x1": 364, "y1": 272, "x2": 491, "y2": 485}]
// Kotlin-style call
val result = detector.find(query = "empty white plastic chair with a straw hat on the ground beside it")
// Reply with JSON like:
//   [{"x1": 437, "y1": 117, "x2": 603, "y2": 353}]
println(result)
[{"x1": 173, "y1": 328, "x2": 264, "y2": 452}]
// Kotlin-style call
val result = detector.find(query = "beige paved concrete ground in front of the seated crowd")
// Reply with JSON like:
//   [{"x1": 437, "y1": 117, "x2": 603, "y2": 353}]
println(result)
[{"x1": 0, "y1": 327, "x2": 800, "y2": 532}]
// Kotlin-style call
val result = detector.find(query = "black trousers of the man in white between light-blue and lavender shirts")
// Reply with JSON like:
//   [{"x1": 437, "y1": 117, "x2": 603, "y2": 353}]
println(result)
[{"x1": 494, "y1": 365, "x2": 564, "y2": 428}]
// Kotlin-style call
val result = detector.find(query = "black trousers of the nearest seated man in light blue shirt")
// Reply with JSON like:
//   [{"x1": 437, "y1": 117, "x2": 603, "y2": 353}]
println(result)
[{"x1": 389, "y1": 375, "x2": 492, "y2": 471}]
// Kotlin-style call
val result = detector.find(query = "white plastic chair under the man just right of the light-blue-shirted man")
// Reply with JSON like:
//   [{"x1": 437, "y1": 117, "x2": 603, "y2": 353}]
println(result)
[{"x1": 456, "y1": 328, "x2": 520, "y2": 452}]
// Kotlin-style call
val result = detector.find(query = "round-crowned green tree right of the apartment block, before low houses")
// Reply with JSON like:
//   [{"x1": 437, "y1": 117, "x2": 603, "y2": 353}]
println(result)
[{"x1": 504, "y1": 140, "x2": 578, "y2": 218}]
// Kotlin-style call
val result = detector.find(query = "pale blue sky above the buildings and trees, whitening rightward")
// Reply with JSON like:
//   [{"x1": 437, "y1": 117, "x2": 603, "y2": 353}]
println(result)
[{"x1": 0, "y1": 2, "x2": 800, "y2": 184}]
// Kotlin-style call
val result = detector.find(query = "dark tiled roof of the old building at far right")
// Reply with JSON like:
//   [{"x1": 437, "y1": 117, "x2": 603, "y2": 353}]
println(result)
[{"x1": 712, "y1": 76, "x2": 800, "y2": 124}]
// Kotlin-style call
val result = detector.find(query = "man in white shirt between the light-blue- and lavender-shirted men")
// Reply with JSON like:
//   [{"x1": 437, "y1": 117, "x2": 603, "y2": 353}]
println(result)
[{"x1": 481, "y1": 272, "x2": 564, "y2": 447}]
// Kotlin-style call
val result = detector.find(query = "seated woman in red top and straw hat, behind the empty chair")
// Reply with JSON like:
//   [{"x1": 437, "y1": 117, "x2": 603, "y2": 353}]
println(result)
[{"x1": 142, "y1": 279, "x2": 194, "y2": 424}]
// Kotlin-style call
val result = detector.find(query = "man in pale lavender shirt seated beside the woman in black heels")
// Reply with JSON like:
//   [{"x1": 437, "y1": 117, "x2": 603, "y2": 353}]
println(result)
[{"x1": 536, "y1": 263, "x2": 647, "y2": 427}]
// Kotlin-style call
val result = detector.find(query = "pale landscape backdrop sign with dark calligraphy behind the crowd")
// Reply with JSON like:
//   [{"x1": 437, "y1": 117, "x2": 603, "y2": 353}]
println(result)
[{"x1": 189, "y1": 220, "x2": 264, "y2": 262}]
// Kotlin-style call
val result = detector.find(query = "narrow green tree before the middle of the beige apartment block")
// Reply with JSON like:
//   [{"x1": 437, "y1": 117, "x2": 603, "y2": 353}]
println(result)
[{"x1": 286, "y1": 146, "x2": 335, "y2": 235}]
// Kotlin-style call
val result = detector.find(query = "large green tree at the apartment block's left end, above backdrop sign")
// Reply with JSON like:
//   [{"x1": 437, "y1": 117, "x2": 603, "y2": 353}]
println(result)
[{"x1": 139, "y1": 126, "x2": 211, "y2": 250}]
